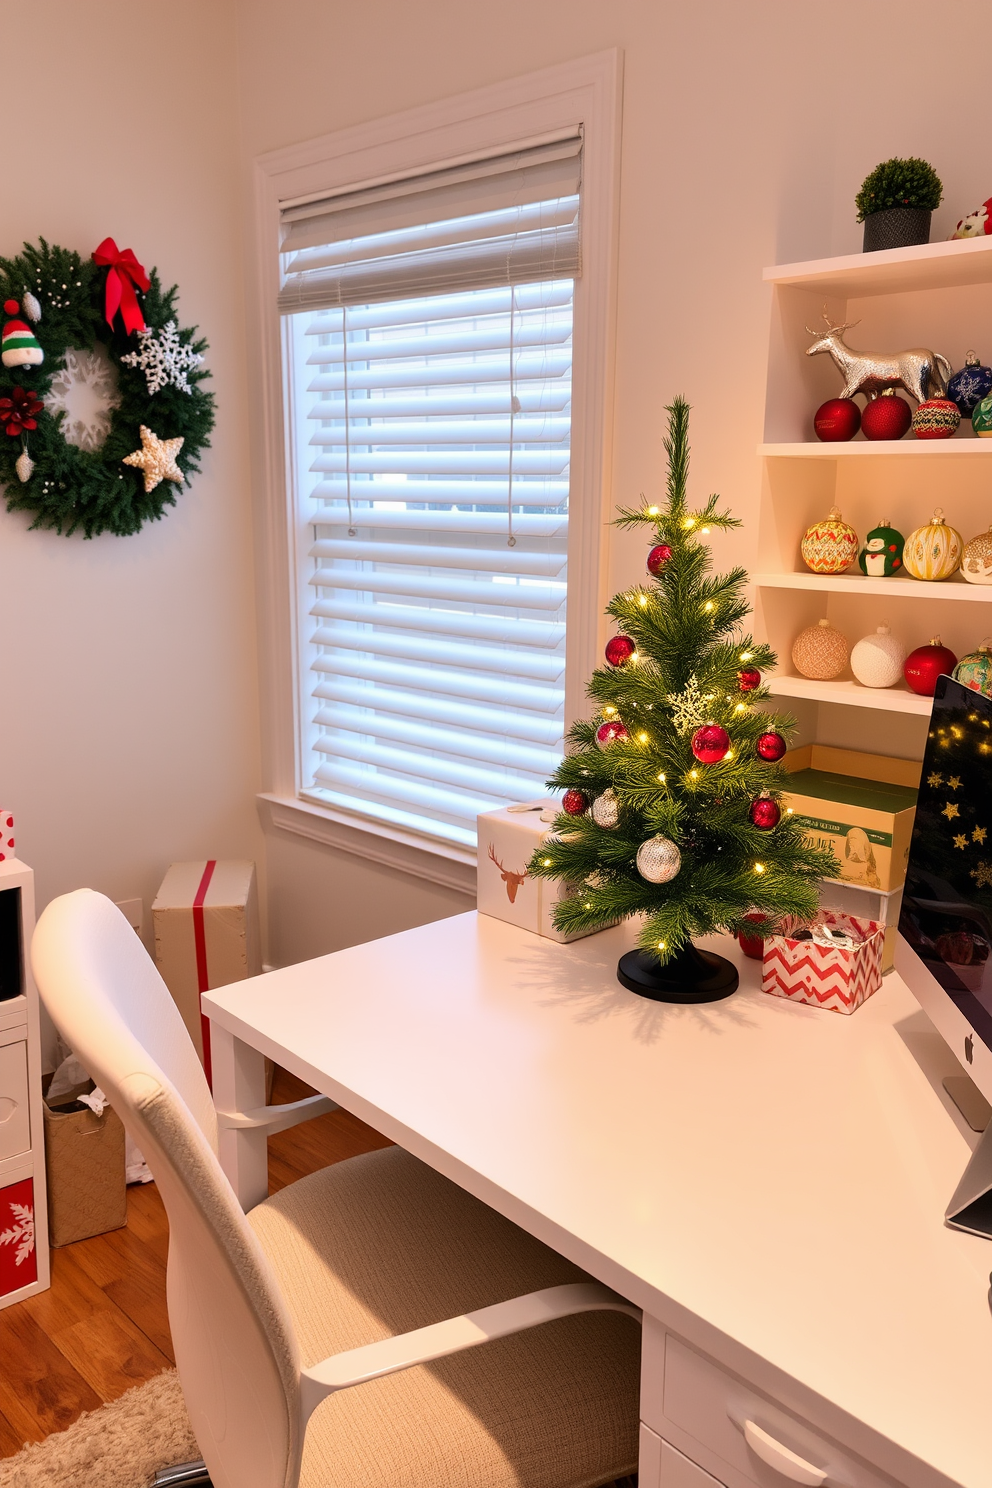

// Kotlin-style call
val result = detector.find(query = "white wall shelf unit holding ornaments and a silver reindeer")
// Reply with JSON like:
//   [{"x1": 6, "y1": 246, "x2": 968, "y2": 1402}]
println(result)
[{"x1": 753, "y1": 237, "x2": 992, "y2": 756}]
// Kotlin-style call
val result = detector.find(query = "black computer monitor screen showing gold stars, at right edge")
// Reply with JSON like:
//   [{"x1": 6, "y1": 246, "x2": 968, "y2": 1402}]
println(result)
[{"x1": 898, "y1": 677, "x2": 992, "y2": 1048}]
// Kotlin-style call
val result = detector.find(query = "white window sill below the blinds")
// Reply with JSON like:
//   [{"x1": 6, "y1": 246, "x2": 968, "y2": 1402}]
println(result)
[{"x1": 256, "y1": 792, "x2": 476, "y2": 899}]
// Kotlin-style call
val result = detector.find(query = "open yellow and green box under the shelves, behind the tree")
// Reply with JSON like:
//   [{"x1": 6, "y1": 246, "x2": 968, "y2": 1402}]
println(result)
[{"x1": 782, "y1": 744, "x2": 919, "y2": 893}]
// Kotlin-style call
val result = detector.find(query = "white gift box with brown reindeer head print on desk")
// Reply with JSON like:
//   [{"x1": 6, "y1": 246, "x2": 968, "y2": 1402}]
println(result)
[{"x1": 477, "y1": 801, "x2": 597, "y2": 940}]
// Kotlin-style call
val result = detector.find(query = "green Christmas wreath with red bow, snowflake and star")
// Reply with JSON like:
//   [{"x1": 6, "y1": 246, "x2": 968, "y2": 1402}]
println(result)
[{"x1": 0, "y1": 238, "x2": 214, "y2": 537}]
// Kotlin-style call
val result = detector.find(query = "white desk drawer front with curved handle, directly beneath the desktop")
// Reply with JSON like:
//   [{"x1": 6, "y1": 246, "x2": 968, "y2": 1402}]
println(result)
[{"x1": 662, "y1": 1333, "x2": 892, "y2": 1488}]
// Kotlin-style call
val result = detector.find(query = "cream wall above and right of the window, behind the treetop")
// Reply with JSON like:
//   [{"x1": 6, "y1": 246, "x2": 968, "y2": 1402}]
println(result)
[{"x1": 238, "y1": 0, "x2": 992, "y2": 958}]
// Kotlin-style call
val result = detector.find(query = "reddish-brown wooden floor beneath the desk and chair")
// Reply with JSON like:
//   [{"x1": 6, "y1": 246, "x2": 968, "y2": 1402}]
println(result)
[{"x1": 0, "y1": 1070, "x2": 388, "y2": 1457}]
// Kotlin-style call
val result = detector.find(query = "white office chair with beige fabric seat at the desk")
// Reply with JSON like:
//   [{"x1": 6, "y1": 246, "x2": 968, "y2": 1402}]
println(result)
[{"x1": 31, "y1": 888, "x2": 640, "y2": 1488}]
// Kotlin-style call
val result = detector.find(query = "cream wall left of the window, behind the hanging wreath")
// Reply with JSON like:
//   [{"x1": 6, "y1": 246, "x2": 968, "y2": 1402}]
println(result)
[{"x1": 0, "y1": 0, "x2": 263, "y2": 917}]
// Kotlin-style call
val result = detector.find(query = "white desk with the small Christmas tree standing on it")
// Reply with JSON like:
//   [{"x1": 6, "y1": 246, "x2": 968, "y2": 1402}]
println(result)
[{"x1": 204, "y1": 914, "x2": 992, "y2": 1488}]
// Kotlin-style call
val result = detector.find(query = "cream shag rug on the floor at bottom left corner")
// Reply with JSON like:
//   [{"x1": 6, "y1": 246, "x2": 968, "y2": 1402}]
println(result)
[{"x1": 0, "y1": 1369, "x2": 199, "y2": 1488}]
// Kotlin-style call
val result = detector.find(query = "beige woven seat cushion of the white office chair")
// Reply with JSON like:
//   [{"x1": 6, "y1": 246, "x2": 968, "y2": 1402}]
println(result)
[{"x1": 248, "y1": 1147, "x2": 641, "y2": 1488}]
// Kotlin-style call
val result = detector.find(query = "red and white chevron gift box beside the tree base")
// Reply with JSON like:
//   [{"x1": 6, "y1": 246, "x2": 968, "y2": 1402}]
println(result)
[{"x1": 761, "y1": 909, "x2": 885, "y2": 1013}]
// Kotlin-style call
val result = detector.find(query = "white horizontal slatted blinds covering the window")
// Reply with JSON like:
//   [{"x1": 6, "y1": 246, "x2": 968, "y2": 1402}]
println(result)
[{"x1": 281, "y1": 141, "x2": 579, "y2": 847}]
